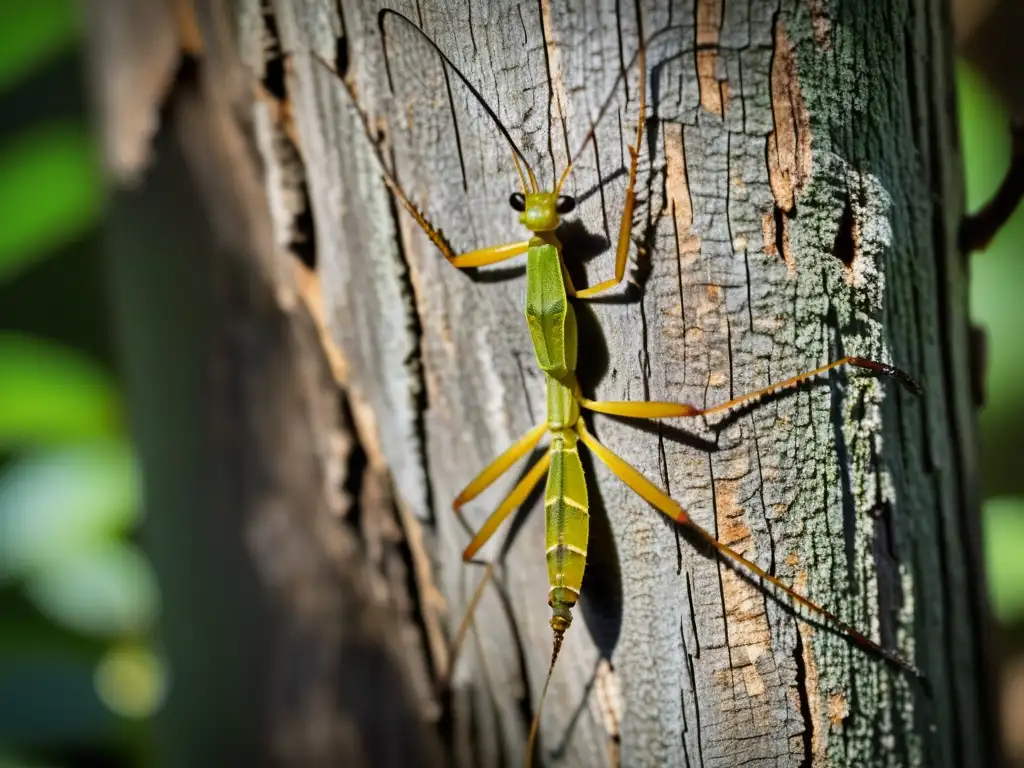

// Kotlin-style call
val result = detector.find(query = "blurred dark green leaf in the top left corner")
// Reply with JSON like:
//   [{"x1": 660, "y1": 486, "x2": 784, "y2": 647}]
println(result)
[{"x1": 0, "y1": 0, "x2": 80, "y2": 93}]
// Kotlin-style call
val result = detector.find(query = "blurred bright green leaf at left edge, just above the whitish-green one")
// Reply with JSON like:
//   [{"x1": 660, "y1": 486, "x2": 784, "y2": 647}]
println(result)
[{"x1": 0, "y1": 333, "x2": 121, "y2": 449}]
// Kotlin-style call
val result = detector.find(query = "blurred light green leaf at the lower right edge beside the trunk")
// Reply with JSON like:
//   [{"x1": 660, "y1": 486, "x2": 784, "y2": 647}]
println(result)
[{"x1": 982, "y1": 497, "x2": 1024, "y2": 623}]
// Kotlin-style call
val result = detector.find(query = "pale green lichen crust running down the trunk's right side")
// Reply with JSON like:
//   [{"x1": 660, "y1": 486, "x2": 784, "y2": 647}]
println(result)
[{"x1": 793, "y1": 151, "x2": 922, "y2": 768}]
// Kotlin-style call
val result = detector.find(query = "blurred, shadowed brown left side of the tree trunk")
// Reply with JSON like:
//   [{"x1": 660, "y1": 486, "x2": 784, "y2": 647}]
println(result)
[{"x1": 82, "y1": 0, "x2": 441, "y2": 766}]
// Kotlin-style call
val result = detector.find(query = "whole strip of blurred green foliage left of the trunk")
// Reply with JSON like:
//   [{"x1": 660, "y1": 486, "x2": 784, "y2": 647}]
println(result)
[{"x1": 0, "y1": 0, "x2": 165, "y2": 768}]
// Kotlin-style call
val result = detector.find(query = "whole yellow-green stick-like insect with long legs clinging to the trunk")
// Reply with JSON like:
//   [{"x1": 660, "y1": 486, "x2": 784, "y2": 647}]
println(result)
[{"x1": 321, "y1": 9, "x2": 921, "y2": 765}]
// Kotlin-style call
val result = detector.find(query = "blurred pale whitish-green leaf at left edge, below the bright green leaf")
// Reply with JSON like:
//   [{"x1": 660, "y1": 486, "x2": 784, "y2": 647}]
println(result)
[{"x1": 0, "y1": 441, "x2": 139, "y2": 583}]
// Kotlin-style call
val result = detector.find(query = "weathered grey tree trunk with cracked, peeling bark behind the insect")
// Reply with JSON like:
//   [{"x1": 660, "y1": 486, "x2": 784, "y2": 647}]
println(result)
[{"x1": 83, "y1": 0, "x2": 997, "y2": 768}]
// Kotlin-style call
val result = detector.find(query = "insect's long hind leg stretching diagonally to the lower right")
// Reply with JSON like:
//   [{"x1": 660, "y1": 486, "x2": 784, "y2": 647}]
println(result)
[{"x1": 577, "y1": 419, "x2": 921, "y2": 677}]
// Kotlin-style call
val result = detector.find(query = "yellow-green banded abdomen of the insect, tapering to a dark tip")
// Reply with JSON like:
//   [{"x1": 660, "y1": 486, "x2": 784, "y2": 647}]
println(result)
[{"x1": 544, "y1": 430, "x2": 590, "y2": 631}]
